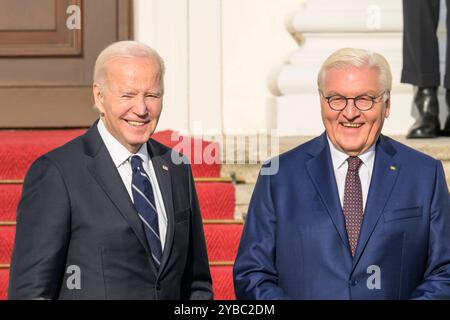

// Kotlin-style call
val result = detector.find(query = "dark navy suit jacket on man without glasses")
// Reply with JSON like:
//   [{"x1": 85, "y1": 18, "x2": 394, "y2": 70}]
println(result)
[{"x1": 9, "y1": 124, "x2": 212, "y2": 299}]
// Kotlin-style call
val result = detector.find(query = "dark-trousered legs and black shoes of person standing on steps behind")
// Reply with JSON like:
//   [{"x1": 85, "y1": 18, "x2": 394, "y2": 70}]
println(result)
[{"x1": 401, "y1": 0, "x2": 450, "y2": 139}]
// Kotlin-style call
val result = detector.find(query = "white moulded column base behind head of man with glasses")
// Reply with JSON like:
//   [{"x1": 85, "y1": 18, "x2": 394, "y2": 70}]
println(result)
[{"x1": 273, "y1": 0, "x2": 426, "y2": 135}]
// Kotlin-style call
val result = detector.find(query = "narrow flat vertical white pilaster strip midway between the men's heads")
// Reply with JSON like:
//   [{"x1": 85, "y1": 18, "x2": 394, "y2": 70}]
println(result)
[{"x1": 188, "y1": 0, "x2": 222, "y2": 133}]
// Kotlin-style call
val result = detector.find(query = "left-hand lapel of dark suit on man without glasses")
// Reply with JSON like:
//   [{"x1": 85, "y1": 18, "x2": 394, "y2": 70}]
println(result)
[{"x1": 84, "y1": 123, "x2": 156, "y2": 273}]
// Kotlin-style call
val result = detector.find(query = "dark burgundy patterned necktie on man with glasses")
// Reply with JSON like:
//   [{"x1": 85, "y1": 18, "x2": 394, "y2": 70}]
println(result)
[{"x1": 343, "y1": 157, "x2": 363, "y2": 256}]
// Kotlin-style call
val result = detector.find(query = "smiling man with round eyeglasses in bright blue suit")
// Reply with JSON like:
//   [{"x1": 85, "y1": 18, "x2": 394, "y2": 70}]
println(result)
[{"x1": 234, "y1": 48, "x2": 450, "y2": 299}]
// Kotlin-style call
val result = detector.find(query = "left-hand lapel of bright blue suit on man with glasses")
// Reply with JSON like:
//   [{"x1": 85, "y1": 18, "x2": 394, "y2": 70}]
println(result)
[{"x1": 306, "y1": 133, "x2": 350, "y2": 254}]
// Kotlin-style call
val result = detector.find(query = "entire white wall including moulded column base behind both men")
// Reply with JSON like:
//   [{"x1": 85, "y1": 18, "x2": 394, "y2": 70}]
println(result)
[{"x1": 135, "y1": 0, "x2": 444, "y2": 135}]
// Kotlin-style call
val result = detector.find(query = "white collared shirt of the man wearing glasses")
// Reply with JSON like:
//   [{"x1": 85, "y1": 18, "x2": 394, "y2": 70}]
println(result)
[{"x1": 327, "y1": 135, "x2": 375, "y2": 210}]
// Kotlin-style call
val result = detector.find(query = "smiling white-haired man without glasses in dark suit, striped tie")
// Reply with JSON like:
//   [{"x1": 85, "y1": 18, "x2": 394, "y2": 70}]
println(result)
[{"x1": 9, "y1": 41, "x2": 212, "y2": 299}]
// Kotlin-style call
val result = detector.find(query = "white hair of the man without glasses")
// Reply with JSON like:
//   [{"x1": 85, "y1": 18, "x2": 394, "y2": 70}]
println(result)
[{"x1": 94, "y1": 41, "x2": 165, "y2": 92}]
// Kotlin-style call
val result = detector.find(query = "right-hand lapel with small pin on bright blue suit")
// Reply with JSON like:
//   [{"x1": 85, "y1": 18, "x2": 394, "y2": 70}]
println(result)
[{"x1": 353, "y1": 135, "x2": 401, "y2": 268}]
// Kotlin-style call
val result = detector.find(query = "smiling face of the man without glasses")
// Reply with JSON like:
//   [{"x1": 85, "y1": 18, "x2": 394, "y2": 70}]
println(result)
[{"x1": 93, "y1": 57, "x2": 162, "y2": 153}]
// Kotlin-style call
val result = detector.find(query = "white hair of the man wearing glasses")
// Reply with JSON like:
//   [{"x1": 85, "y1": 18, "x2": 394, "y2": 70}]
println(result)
[{"x1": 317, "y1": 48, "x2": 392, "y2": 94}]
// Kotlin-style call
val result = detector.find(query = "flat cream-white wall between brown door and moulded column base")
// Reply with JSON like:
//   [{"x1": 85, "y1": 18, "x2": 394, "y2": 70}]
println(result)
[{"x1": 135, "y1": 0, "x2": 301, "y2": 132}]
